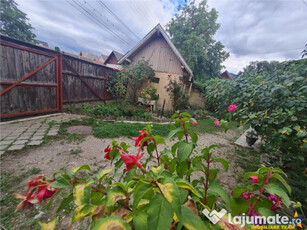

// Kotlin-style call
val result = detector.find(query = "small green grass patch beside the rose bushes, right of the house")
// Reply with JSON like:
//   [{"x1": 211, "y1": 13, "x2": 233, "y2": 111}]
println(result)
[{"x1": 191, "y1": 118, "x2": 239, "y2": 134}]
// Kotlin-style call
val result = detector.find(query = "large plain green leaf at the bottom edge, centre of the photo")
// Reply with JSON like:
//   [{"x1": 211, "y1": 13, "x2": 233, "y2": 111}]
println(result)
[{"x1": 147, "y1": 194, "x2": 174, "y2": 230}]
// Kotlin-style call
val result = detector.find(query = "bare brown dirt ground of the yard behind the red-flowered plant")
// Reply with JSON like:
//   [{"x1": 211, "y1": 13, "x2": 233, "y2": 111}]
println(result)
[{"x1": 1, "y1": 121, "x2": 243, "y2": 229}]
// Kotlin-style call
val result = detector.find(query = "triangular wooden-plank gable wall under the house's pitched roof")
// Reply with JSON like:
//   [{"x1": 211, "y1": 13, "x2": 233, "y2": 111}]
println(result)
[{"x1": 131, "y1": 35, "x2": 184, "y2": 76}]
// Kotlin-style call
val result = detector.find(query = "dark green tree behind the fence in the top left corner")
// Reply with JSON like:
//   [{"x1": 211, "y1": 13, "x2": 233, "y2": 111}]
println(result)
[{"x1": 0, "y1": 0, "x2": 37, "y2": 43}]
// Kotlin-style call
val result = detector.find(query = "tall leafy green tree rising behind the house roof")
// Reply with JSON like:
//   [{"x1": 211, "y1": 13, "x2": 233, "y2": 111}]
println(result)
[{"x1": 166, "y1": 0, "x2": 229, "y2": 81}]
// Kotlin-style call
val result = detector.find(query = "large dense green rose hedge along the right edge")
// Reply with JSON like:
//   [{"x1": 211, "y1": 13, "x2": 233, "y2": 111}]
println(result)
[{"x1": 204, "y1": 59, "x2": 307, "y2": 208}]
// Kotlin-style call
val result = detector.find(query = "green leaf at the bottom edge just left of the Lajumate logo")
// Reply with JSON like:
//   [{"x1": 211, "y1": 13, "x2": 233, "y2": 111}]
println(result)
[{"x1": 179, "y1": 206, "x2": 209, "y2": 230}]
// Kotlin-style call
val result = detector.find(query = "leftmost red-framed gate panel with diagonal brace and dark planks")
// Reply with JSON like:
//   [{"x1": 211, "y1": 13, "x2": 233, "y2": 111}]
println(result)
[{"x1": 0, "y1": 41, "x2": 62, "y2": 118}]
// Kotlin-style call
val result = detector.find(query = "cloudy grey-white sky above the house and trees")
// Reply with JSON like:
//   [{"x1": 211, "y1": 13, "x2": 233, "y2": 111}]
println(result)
[{"x1": 15, "y1": 0, "x2": 307, "y2": 73}]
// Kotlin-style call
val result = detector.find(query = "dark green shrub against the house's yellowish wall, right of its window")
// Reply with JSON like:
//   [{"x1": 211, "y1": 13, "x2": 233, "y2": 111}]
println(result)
[{"x1": 166, "y1": 79, "x2": 189, "y2": 111}]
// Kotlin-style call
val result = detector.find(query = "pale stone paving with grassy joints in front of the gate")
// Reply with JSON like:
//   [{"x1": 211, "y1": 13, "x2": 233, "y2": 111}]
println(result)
[{"x1": 0, "y1": 113, "x2": 82, "y2": 155}]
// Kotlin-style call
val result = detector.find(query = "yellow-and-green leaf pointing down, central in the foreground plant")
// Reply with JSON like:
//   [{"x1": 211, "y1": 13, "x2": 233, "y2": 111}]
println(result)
[{"x1": 157, "y1": 178, "x2": 181, "y2": 217}]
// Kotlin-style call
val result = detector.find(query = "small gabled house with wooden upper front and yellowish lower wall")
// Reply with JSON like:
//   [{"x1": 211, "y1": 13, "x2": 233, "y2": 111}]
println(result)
[{"x1": 119, "y1": 24, "x2": 203, "y2": 110}]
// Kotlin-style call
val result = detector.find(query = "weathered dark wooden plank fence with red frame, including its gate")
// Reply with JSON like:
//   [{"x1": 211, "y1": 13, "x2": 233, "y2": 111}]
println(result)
[{"x1": 0, "y1": 36, "x2": 114, "y2": 118}]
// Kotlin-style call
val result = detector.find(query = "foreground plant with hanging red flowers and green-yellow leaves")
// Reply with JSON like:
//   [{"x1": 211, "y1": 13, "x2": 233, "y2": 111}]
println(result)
[{"x1": 14, "y1": 113, "x2": 299, "y2": 230}]
